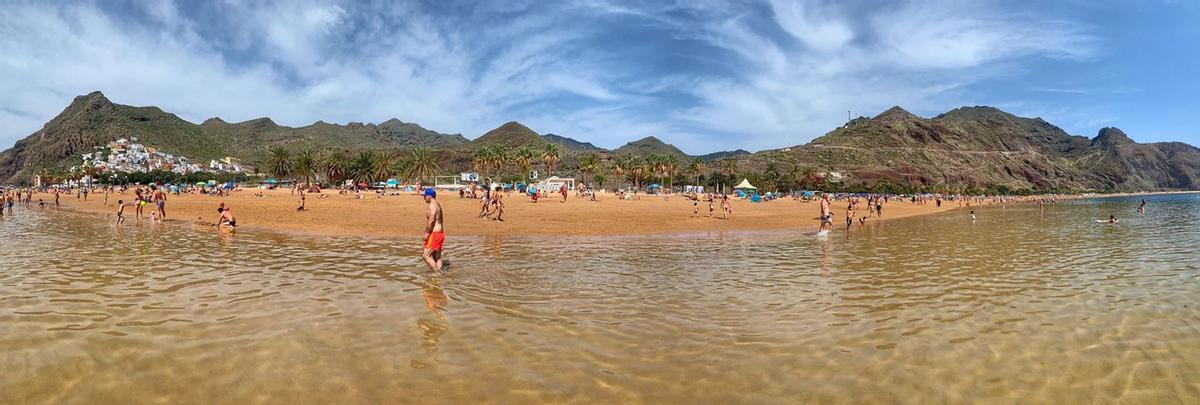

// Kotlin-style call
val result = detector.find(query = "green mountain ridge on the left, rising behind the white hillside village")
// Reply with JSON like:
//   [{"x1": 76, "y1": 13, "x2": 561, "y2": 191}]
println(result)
[{"x1": 0, "y1": 91, "x2": 467, "y2": 183}]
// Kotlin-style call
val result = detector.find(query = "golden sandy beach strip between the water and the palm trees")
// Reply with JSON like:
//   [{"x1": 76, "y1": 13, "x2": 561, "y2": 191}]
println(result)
[{"x1": 34, "y1": 189, "x2": 959, "y2": 237}]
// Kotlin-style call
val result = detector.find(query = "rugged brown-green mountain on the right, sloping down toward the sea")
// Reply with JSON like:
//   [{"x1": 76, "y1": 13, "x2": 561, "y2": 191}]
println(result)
[{"x1": 740, "y1": 107, "x2": 1200, "y2": 192}]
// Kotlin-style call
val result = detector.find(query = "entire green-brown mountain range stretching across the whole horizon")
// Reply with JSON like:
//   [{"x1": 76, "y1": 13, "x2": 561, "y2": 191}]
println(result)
[{"x1": 0, "y1": 92, "x2": 1200, "y2": 192}]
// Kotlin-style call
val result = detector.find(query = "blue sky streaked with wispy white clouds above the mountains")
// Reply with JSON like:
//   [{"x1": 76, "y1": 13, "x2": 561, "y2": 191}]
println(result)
[{"x1": 0, "y1": 0, "x2": 1200, "y2": 155}]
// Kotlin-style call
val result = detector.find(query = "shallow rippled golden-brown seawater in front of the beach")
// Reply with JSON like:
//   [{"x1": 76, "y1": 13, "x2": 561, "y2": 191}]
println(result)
[{"x1": 0, "y1": 194, "x2": 1200, "y2": 404}]
